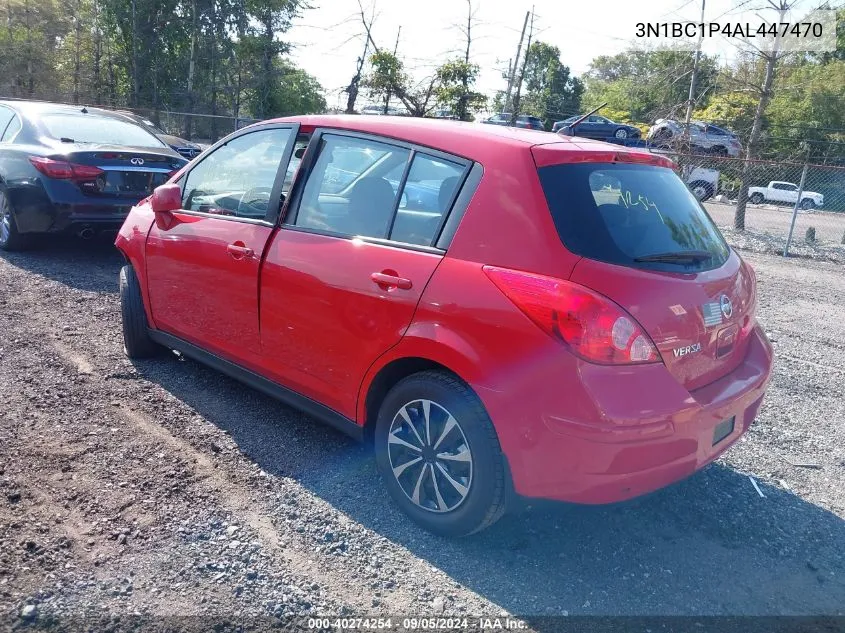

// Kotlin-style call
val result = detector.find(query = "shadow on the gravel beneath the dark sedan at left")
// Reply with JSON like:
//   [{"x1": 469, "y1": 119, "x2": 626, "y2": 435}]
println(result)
[{"x1": 0, "y1": 234, "x2": 123, "y2": 293}]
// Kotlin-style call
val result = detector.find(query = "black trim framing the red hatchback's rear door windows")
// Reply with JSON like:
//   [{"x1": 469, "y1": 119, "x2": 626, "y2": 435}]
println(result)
[{"x1": 277, "y1": 127, "x2": 474, "y2": 254}]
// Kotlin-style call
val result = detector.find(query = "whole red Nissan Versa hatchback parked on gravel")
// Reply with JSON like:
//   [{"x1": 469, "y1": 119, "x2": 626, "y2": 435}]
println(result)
[{"x1": 116, "y1": 116, "x2": 772, "y2": 535}]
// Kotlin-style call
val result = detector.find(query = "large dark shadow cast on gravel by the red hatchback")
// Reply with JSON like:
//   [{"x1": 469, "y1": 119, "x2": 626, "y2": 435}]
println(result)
[{"x1": 130, "y1": 359, "x2": 845, "y2": 620}]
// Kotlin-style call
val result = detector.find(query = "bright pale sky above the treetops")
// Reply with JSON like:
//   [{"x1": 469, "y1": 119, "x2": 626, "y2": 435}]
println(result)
[{"x1": 286, "y1": 0, "x2": 818, "y2": 106}]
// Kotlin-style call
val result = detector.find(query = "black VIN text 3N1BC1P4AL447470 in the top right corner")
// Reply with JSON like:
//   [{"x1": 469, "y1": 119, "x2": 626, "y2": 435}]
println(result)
[{"x1": 634, "y1": 22, "x2": 824, "y2": 39}]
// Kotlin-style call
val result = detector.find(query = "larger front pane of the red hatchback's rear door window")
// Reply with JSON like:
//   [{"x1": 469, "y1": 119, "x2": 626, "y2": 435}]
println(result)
[{"x1": 295, "y1": 134, "x2": 411, "y2": 238}]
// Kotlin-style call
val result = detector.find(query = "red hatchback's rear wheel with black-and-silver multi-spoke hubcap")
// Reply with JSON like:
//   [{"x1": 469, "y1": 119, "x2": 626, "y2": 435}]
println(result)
[{"x1": 374, "y1": 371, "x2": 509, "y2": 537}]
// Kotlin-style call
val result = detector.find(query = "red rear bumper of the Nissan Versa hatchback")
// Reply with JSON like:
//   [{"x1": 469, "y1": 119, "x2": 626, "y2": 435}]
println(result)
[{"x1": 493, "y1": 328, "x2": 772, "y2": 504}]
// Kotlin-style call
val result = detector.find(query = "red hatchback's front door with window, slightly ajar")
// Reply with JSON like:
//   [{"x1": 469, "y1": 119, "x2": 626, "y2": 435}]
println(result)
[{"x1": 146, "y1": 124, "x2": 298, "y2": 368}]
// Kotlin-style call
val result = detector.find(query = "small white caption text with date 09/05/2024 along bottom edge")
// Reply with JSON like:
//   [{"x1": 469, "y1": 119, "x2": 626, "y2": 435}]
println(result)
[{"x1": 308, "y1": 617, "x2": 528, "y2": 631}]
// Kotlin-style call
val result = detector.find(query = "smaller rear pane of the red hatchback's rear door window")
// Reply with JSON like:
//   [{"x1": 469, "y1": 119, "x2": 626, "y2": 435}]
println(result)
[{"x1": 389, "y1": 154, "x2": 464, "y2": 246}]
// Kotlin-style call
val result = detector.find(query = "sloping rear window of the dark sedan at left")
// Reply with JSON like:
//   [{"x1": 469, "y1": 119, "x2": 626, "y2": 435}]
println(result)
[{"x1": 41, "y1": 113, "x2": 167, "y2": 147}]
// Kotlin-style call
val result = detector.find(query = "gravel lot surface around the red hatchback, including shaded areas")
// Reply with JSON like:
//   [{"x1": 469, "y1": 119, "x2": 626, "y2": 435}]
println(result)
[{"x1": 0, "y1": 241, "x2": 845, "y2": 631}]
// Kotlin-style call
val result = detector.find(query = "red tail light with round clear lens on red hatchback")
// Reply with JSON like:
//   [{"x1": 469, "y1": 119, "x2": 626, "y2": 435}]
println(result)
[{"x1": 484, "y1": 266, "x2": 660, "y2": 365}]
